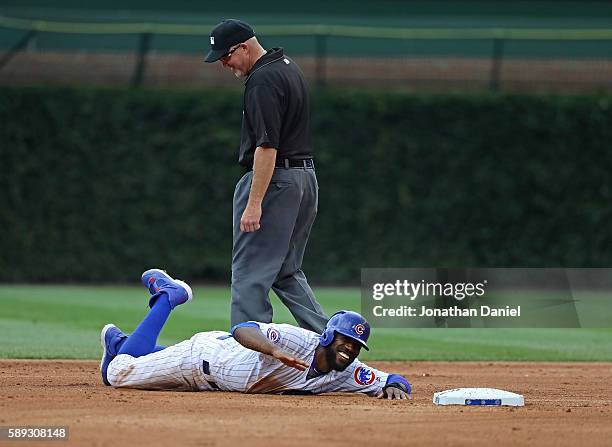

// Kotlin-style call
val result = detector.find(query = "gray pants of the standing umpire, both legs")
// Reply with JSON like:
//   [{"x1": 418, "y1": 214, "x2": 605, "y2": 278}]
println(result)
[{"x1": 231, "y1": 168, "x2": 328, "y2": 333}]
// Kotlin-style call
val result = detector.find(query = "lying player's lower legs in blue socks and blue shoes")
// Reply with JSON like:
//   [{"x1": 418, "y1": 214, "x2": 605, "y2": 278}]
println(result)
[{"x1": 100, "y1": 269, "x2": 193, "y2": 385}]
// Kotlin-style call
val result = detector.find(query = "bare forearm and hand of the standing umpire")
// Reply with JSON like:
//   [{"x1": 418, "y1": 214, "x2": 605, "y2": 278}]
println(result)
[{"x1": 240, "y1": 146, "x2": 276, "y2": 233}]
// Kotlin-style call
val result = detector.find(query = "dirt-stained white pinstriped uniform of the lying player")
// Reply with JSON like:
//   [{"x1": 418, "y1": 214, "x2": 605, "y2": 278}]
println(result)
[{"x1": 107, "y1": 323, "x2": 388, "y2": 395}]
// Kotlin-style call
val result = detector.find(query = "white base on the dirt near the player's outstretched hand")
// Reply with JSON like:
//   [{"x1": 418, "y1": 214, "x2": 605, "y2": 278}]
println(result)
[{"x1": 433, "y1": 388, "x2": 525, "y2": 407}]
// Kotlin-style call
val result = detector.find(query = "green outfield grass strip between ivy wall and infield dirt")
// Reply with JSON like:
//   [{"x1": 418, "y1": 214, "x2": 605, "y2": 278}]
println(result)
[{"x1": 0, "y1": 285, "x2": 612, "y2": 361}]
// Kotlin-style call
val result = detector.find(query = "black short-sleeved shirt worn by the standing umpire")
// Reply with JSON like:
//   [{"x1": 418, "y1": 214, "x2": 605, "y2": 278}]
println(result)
[{"x1": 238, "y1": 48, "x2": 312, "y2": 168}]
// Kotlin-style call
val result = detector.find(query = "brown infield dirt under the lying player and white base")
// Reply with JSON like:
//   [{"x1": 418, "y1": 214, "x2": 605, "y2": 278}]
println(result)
[{"x1": 0, "y1": 360, "x2": 612, "y2": 447}]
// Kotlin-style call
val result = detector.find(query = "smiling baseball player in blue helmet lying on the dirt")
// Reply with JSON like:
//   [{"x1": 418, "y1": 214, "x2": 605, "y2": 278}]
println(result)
[{"x1": 100, "y1": 269, "x2": 411, "y2": 399}]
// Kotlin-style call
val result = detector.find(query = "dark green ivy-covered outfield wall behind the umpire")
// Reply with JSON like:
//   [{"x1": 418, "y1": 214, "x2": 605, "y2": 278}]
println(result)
[{"x1": 0, "y1": 87, "x2": 612, "y2": 284}]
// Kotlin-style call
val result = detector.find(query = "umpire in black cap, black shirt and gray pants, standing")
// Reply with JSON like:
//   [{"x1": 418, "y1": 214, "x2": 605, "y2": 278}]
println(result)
[{"x1": 205, "y1": 19, "x2": 328, "y2": 333}]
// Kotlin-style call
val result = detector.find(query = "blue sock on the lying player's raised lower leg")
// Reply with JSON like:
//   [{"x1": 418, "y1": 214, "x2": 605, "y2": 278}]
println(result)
[{"x1": 117, "y1": 292, "x2": 172, "y2": 357}]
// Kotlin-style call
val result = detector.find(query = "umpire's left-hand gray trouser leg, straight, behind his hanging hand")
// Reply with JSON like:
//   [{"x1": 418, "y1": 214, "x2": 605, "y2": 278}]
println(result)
[{"x1": 230, "y1": 169, "x2": 300, "y2": 326}]
